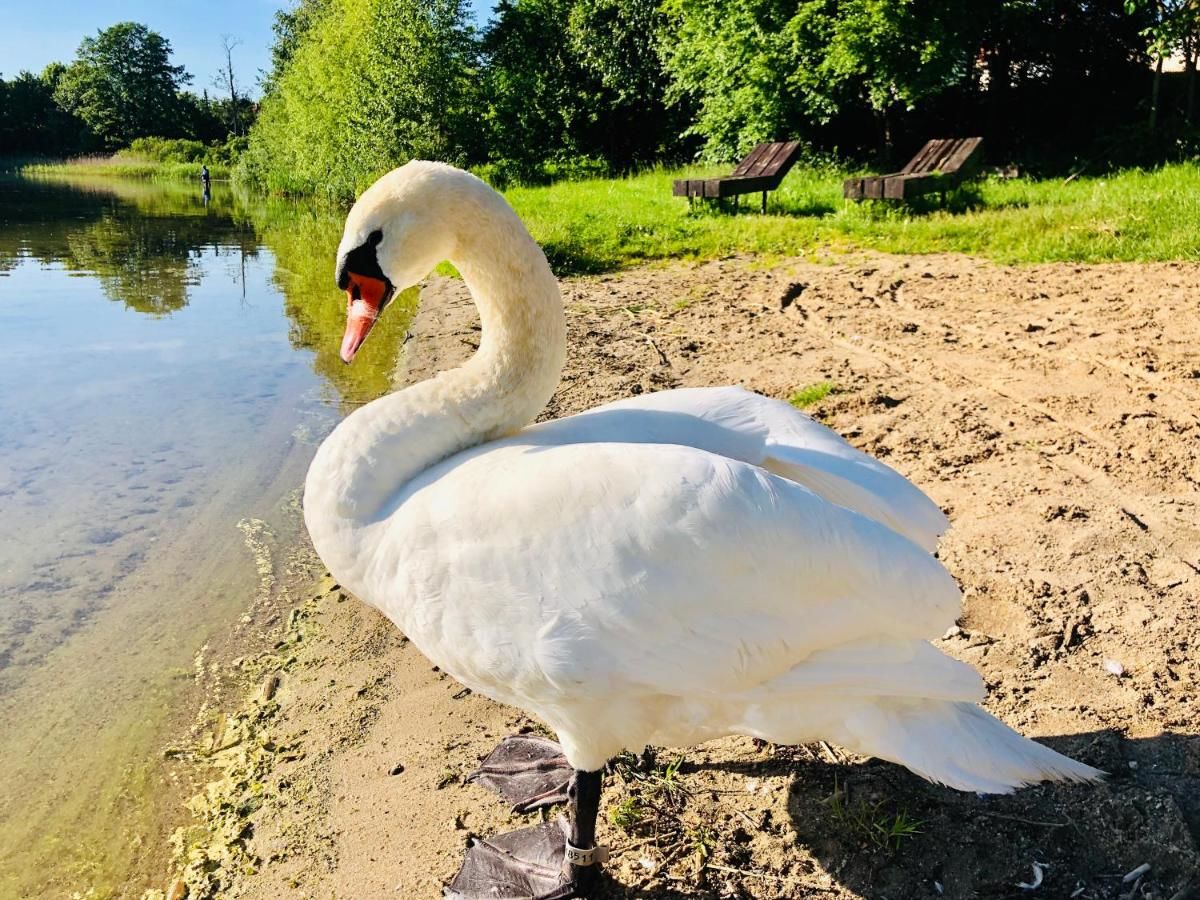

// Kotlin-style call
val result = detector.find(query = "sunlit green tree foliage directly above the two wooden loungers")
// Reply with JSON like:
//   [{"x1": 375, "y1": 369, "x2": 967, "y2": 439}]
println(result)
[{"x1": 665, "y1": 0, "x2": 977, "y2": 160}]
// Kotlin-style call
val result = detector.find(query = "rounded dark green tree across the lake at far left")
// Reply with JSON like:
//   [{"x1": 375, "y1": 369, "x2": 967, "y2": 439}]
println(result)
[{"x1": 54, "y1": 22, "x2": 191, "y2": 148}]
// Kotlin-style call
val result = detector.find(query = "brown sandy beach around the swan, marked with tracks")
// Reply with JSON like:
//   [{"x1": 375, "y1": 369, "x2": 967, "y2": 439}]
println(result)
[{"x1": 154, "y1": 253, "x2": 1200, "y2": 900}]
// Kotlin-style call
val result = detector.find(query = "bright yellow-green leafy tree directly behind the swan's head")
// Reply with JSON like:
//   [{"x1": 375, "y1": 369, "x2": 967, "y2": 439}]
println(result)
[{"x1": 242, "y1": 0, "x2": 479, "y2": 199}]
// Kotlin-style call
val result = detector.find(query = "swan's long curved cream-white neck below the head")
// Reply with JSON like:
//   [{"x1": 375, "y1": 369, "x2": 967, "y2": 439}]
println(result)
[{"x1": 305, "y1": 198, "x2": 566, "y2": 574}]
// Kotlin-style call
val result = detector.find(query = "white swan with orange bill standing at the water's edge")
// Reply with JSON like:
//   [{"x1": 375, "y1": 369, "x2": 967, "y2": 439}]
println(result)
[{"x1": 305, "y1": 162, "x2": 1099, "y2": 898}]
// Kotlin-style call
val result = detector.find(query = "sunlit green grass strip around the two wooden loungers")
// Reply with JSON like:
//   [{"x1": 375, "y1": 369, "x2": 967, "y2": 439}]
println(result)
[{"x1": 505, "y1": 163, "x2": 1200, "y2": 275}]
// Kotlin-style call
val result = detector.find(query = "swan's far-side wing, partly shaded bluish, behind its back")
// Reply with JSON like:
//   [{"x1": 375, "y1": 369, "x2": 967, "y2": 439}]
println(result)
[{"x1": 536, "y1": 388, "x2": 949, "y2": 552}]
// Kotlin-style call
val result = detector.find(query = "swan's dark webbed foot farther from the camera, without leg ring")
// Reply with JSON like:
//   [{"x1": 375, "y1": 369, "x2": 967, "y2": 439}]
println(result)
[{"x1": 467, "y1": 734, "x2": 572, "y2": 816}]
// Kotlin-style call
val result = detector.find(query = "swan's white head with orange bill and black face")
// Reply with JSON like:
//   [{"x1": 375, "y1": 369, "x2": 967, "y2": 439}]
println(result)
[{"x1": 336, "y1": 160, "x2": 475, "y2": 362}]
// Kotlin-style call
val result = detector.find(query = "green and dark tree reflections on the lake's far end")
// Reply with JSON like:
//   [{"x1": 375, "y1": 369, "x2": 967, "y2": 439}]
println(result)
[{"x1": 0, "y1": 178, "x2": 415, "y2": 406}]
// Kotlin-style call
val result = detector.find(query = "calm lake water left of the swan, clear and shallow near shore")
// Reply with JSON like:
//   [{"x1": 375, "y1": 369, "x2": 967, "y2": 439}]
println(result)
[{"x1": 0, "y1": 178, "x2": 407, "y2": 898}]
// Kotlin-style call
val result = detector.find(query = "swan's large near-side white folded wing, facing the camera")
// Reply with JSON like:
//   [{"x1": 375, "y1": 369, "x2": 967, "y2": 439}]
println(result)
[{"x1": 384, "y1": 438, "x2": 960, "y2": 709}]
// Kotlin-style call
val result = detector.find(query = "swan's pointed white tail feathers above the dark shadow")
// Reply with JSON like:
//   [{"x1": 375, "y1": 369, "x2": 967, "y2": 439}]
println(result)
[{"x1": 846, "y1": 701, "x2": 1104, "y2": 793}]
